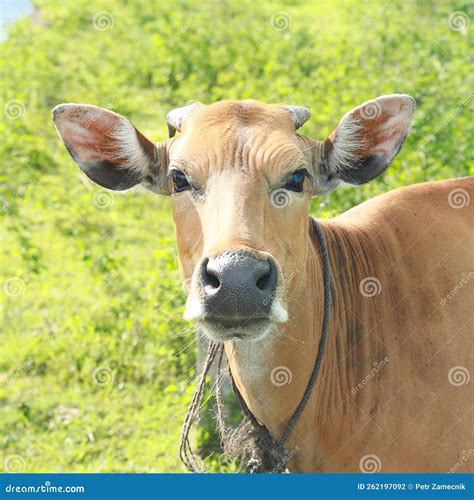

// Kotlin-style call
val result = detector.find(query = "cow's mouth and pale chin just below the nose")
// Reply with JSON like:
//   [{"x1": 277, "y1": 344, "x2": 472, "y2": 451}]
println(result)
[{"x1": 199, "y1": 318, "x2": 274, "y2": 342}]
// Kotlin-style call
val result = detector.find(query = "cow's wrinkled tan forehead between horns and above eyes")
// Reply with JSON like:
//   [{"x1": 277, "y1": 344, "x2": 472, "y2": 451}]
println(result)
[{"x1": 170, "y1": 101, "x2": 304, "y2": 173}]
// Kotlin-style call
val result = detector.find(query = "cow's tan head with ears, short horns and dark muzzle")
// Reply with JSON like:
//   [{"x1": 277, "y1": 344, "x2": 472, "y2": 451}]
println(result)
[{"x1": 53, "y1": 95, "x2": 415, "y2": 341}]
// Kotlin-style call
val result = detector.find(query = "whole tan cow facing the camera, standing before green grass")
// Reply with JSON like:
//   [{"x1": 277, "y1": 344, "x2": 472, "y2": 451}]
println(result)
[{"x1": 53, "y1": 94, "x2": 474, "y2": 472}]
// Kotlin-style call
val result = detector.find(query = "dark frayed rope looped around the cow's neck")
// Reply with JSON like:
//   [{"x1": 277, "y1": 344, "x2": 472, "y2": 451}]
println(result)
[{"x1": 180, "y1": 218, "x2": 331, "y2": 473}]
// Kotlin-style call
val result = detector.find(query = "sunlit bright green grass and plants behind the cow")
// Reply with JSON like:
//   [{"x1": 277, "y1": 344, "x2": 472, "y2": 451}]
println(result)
[{"x1": 0, "y1": 0, "x2": 474, "y2": 472}]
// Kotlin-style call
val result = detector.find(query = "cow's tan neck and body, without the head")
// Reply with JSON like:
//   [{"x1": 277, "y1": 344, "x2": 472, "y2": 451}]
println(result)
[{"x1": 228, "y1": 179, "x2": 474, "y2": 472}]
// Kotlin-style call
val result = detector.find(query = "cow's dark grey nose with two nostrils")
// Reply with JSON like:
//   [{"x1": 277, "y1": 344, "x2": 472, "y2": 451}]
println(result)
[{"x1": 201, "y1": 251, "x2": 277, "y2": 319}]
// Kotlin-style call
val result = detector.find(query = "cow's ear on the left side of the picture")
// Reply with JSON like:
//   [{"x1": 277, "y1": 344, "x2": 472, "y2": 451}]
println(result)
[{"x1": 53, "y1": 104, "x2": 169, "y2": 194}]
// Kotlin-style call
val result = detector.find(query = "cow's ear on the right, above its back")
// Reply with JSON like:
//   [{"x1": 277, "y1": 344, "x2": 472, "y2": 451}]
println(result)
[{"x1": 318, "y1": 94, "x2": 415, "y2": 193}]
